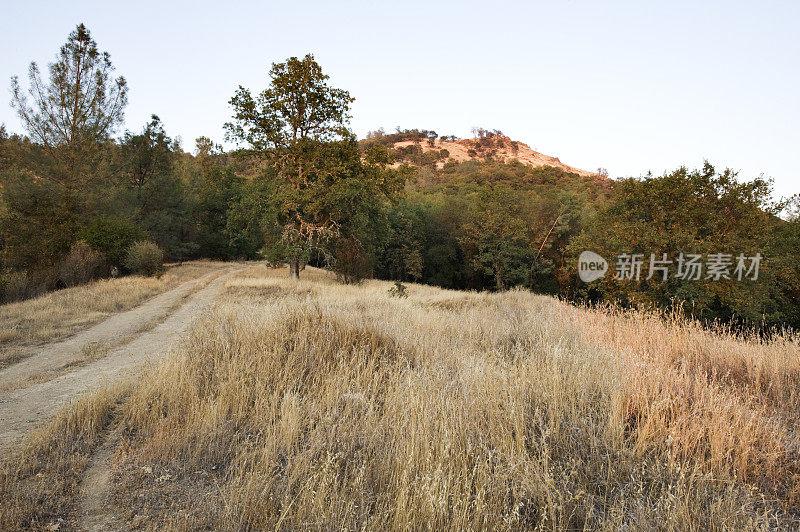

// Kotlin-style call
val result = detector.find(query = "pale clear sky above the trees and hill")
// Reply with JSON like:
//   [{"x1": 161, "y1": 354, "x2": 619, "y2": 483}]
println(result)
[{"x1": 0, "y1": 0, "x2": 800, "y2": 197}]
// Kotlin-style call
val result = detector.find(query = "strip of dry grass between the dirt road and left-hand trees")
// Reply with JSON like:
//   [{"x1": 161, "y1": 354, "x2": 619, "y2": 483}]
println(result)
[{"x1": 0, "y1": 262, "x2": 225, "y2": 367}]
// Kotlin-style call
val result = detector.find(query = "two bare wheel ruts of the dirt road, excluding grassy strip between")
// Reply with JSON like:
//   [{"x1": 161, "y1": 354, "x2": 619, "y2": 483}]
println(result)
[{"x1": 0, "y1": 268, "x2": 240, "y2": 452}]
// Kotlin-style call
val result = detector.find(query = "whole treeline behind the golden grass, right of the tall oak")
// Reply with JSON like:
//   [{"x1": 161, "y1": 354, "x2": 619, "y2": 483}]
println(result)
[{"x1": 390, "y1": 161, "x2": 800, "y2": 329}]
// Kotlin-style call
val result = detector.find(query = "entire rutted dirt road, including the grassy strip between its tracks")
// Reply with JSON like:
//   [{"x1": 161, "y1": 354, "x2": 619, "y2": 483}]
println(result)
[{"x1": 0, "y1": 267, "x2": 240, "y2": 451}]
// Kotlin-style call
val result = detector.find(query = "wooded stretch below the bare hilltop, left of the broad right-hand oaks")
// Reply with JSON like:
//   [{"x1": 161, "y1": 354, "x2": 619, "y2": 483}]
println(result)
[{"x1": 377, "y1": 161, "x2": 601, "y2": 293}]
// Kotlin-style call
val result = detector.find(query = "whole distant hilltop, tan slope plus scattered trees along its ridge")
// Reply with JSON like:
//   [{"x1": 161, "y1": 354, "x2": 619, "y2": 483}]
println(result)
[{"x1": 361, "y1": 128, "x2": 605, "y2": 177}]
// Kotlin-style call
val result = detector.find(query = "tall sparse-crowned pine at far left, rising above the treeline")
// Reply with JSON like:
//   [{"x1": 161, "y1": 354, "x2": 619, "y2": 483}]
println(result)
[{"x1": 0, "y1": 24, "x2": 128, "y2": 268}]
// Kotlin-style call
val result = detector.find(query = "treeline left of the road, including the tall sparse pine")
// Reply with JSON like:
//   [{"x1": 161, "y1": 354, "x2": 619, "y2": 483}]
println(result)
[{"x1": 0, "y1": 25, "x2": 261, "y2": 301}]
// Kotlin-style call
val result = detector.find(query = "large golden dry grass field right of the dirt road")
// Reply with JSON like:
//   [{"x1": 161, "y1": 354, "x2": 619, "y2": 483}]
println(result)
[{"x1": 0, "y1": 266, "x2": 800, "y2": 530}]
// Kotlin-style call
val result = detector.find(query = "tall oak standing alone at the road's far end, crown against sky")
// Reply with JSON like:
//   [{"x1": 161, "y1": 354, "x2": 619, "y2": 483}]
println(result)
[{"x1": 225, "y1": 54, "x2": 354, "y2": 279}]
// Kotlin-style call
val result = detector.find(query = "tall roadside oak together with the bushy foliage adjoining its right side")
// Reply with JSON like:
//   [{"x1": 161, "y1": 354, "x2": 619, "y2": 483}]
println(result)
[{"x1": 226, "y1": 55, "x2": 397, "y2": 280}]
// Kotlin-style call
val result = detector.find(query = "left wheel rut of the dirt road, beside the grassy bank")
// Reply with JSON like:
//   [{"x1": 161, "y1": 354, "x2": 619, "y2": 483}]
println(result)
[{"x1": 0, "y1": 269, "x2": 224, "y2": 397}]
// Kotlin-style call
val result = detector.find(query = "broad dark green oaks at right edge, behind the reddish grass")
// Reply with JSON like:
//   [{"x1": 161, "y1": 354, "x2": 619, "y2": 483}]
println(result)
[{"x1": 569, "y1": 163, "x2": 798, "y2": 326}]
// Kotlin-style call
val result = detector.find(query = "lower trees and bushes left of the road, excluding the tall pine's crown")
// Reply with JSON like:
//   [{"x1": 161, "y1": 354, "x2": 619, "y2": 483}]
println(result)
[{"x1": 0, "y1": 116, "x2": 262, "y2": 301}]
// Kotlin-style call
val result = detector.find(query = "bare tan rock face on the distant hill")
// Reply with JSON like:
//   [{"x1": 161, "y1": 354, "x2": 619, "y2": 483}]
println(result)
[{"x1": 394, "y1": 135, "x2": 598, "y2": 176}]
